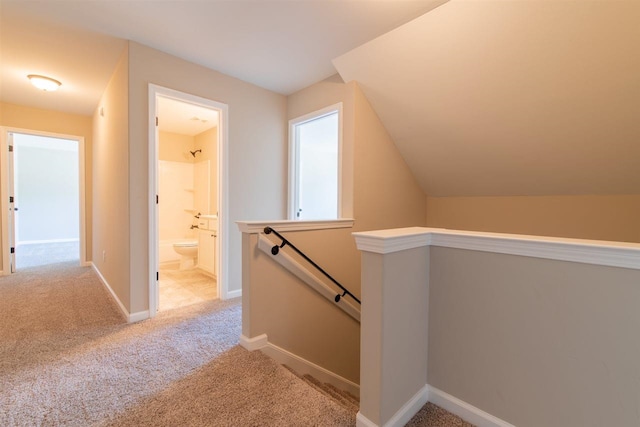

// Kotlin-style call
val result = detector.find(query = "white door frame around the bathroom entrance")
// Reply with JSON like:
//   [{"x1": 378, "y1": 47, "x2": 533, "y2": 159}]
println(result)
[{"x1": 149, "y1": 83, "x2": 233, "y2": 317}]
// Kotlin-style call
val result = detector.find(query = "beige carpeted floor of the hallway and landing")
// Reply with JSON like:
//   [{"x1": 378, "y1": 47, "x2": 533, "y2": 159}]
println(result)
[{"x1": 0, "y1": 263, "x2": 468, "y2": 427}]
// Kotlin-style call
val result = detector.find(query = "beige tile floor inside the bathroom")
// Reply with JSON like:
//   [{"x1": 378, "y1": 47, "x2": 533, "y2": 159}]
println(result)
[{"x1": 159, "y1": 266, "x2": 218, "y2": 311}]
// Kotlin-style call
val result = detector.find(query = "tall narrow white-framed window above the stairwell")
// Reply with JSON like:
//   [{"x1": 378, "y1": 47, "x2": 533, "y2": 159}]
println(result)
[{"x1": 289, "y1": 104, "x2": 342, "y2": 220}]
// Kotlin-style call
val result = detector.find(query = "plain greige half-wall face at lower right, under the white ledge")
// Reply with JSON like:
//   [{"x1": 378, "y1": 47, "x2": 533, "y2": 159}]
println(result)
[{"x1": 428, "y1": 247, "x2": 640, "y2": 427}]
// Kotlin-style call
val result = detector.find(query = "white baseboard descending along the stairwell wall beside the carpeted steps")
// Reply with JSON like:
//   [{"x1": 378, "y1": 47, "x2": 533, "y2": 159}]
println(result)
[{"x1": 240, "y1": 334, "x2": 360, "y2": 396}]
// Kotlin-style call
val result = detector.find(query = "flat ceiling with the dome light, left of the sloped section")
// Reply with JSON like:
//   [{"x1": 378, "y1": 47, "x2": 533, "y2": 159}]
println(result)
[{"x1": 0, "y1": 0, "x2": 446, "y2": 114}]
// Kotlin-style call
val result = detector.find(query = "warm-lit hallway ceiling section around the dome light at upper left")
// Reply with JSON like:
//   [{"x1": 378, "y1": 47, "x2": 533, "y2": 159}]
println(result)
[{"x1": 0, "y1": 6, "x2": 125, "y2": 115}]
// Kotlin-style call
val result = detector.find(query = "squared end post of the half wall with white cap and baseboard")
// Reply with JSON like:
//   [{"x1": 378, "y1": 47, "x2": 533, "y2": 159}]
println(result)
[{"x1": 354, "y1": 227, "x2": 430, "y2": 427}]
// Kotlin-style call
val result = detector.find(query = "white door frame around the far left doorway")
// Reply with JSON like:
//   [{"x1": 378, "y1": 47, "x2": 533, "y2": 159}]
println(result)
[{"x1": 0, "y1": 126, "x2": 90, "y2": 276}]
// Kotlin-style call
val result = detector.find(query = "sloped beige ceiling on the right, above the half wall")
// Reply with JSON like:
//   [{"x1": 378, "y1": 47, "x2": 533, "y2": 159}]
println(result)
[{"x1": 334, "y1": 0, "x2": 640, "y2": 196}]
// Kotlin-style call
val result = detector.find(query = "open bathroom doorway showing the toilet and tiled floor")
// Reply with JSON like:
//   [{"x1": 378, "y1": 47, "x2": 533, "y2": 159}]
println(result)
[{"x1": 149, "y1": 85, "x2": 226, "y2": 317}]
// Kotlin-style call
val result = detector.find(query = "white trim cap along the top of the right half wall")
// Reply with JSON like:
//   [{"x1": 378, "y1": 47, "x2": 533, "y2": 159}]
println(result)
[{"x1": 353, "y1": 227, "x2": 640, "y2": 270}]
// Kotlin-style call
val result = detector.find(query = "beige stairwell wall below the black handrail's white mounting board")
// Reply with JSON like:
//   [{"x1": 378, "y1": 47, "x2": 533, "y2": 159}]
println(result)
[{"x1": 242, "y1": 234, "x2": 360, "y2": 384}]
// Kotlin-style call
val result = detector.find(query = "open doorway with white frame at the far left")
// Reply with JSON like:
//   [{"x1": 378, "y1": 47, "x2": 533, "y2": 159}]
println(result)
[{"x1": 1, "y1": 129, "x2": 86, "y2": 274}]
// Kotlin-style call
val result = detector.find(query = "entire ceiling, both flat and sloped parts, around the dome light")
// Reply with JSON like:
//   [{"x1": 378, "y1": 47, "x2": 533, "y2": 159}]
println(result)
[{"x1": 0, "y1": 0, "x2": 640, "y2": 196}]
